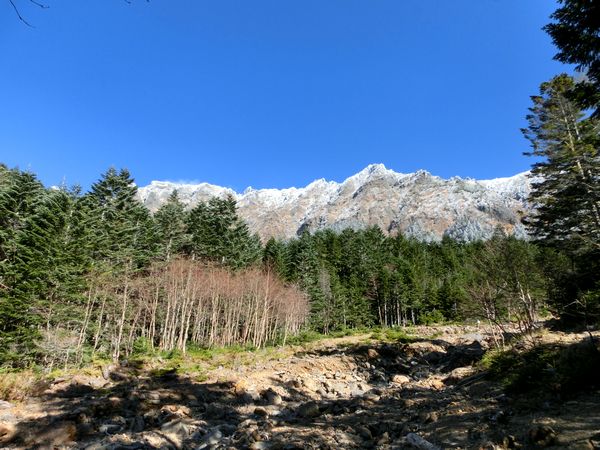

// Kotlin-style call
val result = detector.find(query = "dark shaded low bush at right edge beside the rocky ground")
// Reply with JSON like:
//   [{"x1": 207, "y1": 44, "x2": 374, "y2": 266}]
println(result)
[{"x1": 480, "y1": 338, "x2": 600, "y2": 394}]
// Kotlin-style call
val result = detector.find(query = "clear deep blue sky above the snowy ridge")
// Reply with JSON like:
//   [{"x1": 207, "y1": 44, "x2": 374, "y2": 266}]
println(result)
[{"x1": 0, "y1": 0, "x2": 568, "y2": 191}]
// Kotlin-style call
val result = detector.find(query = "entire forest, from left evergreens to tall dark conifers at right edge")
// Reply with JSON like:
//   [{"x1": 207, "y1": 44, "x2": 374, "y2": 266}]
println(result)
[{"x1": 0, "y1": 0, "x2": 600, "y2": 367}]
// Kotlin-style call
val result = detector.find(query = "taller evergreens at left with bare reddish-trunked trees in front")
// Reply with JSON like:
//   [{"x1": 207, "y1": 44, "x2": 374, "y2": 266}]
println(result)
[{"x1": 0, "y1": 166, "x2": 309, "y2": 366}]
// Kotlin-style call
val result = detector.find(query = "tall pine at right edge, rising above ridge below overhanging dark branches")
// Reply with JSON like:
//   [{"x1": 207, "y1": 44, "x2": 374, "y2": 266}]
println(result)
[{"x1": 523, "y1": 74, "x2": 600, "y2": 322}]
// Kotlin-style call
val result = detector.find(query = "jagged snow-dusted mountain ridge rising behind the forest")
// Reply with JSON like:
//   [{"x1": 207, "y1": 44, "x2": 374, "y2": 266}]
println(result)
[{"x1": 139, "y1": 164, "x2": 531, "y2": 241}]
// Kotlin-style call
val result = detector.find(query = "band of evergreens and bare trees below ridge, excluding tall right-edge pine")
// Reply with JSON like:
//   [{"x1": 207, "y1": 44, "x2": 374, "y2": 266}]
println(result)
[{"x1": 0, "y1": 159, "x2": 596, "y2": 366}]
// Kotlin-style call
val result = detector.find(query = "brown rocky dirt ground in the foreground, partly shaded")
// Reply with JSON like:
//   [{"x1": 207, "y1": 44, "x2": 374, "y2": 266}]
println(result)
[{"x1": 0, "y1": 326, "x2": 600, "y2": 450}]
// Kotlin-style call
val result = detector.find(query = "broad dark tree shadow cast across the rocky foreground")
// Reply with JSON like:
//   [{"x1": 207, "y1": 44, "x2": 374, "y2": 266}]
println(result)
[{"x1": 0, "y1": 332, "x2": 600, "y2": 450}]
